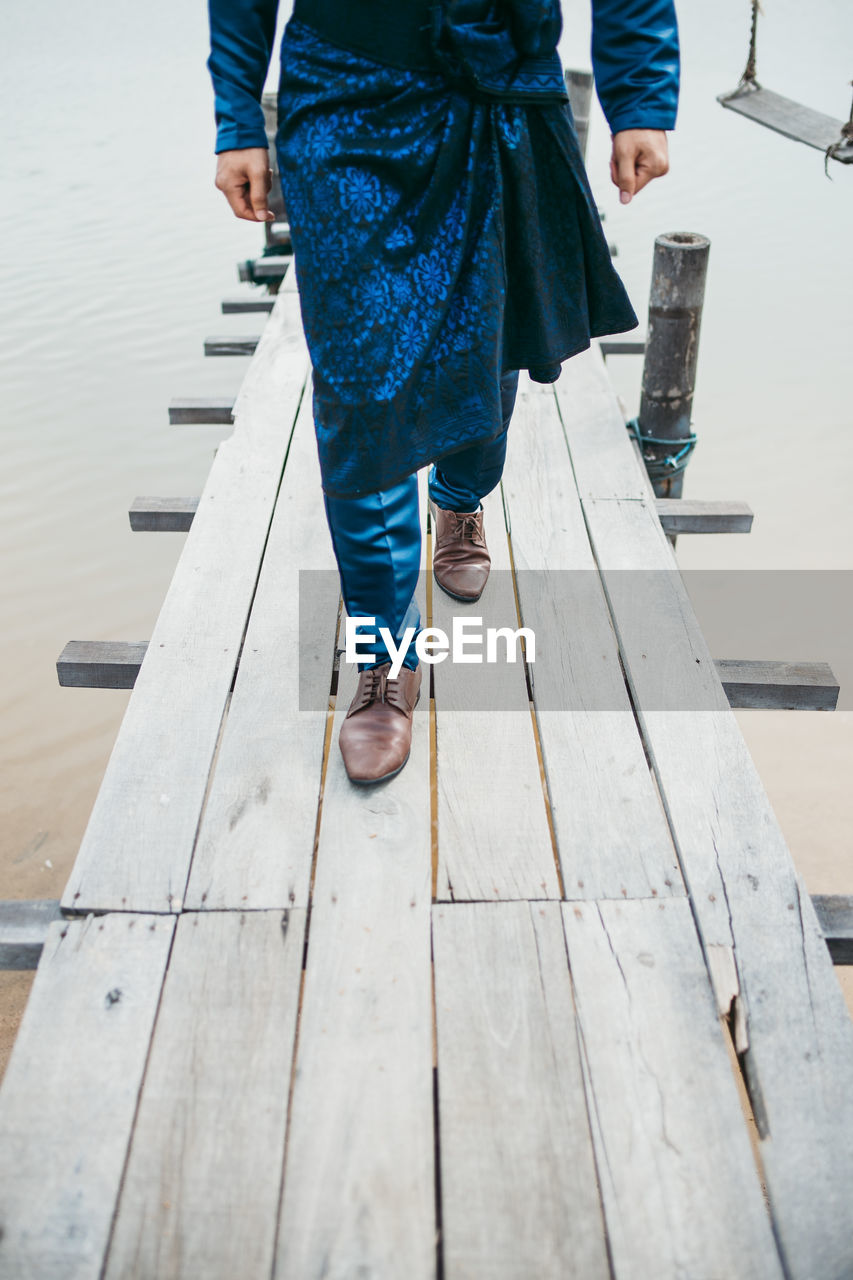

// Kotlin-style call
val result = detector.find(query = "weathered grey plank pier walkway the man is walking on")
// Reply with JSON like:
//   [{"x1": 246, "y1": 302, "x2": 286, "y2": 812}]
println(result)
[{"x1": 0, "y1": 254, "x2": 853, "y2": 1280}]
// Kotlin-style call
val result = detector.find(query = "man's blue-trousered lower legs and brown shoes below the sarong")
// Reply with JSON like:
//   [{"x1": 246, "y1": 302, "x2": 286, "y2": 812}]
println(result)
[{"x1": 324, "y1": 371, "x2": 519, "y2": 783}]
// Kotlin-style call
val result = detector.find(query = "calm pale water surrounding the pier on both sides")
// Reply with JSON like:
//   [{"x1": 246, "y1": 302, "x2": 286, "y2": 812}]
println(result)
[{"x1": 0, "y1": 0, "x2": 853, "y2": 1008}]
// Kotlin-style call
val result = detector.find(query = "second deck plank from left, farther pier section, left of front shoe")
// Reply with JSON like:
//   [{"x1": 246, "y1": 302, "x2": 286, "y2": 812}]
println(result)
[{"x1": 187, "y1": 388, "x2": 338, "y2": 910}]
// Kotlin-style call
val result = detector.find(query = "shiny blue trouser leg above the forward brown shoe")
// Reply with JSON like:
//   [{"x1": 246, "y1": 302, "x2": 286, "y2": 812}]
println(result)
[{"x1": 324, "y1": 475, "x2": 420, "y2": 671}]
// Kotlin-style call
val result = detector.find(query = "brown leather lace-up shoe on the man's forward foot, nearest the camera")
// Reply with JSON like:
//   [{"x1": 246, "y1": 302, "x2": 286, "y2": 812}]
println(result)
[{"x1": 338, "y1": 662, "x2": 421, "y2": 786}]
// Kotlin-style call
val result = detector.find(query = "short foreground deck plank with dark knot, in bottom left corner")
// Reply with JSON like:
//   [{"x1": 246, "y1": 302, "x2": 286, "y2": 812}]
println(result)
[{"x1": 0, "y1": 914, "x2": 174, "y2": 1280}]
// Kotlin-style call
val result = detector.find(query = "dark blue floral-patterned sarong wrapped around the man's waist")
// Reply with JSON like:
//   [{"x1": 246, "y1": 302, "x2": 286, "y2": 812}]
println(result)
[{"x1": 277, "y1": 19, "x2": 637, "y2": 497}]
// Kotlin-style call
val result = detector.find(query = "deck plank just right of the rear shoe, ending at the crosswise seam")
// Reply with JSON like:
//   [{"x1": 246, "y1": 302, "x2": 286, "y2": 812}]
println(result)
[{"x1": 502, "y1": 381, "x2": 684, "y2": 899}]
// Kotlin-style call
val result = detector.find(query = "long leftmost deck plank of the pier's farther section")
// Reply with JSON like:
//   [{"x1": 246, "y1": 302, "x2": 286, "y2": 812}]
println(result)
[{"x1": 63, "y1": 294, "x2": 307, "y2": 911}]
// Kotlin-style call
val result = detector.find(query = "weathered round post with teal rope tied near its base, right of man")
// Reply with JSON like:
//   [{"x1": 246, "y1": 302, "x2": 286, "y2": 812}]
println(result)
[{"x1": 637, "y1": 232, "x2": 711, "y2": 498}]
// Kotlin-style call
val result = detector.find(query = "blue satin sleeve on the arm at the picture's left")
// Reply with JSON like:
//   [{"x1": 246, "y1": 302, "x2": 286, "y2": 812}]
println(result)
[{"x1": 207, "y1": 0, "x2": 278, "y2": 152}]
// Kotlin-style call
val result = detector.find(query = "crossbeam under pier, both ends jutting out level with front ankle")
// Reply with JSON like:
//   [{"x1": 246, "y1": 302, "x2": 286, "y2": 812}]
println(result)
[{"x1": 56, "y1": 640, "x2": 839, "y2": 712}]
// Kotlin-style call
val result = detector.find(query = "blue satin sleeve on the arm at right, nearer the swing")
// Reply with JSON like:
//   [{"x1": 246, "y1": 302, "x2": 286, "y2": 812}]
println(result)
[{"x1": 592, "y1": 0, "x2": 679, "y2": 133}]
